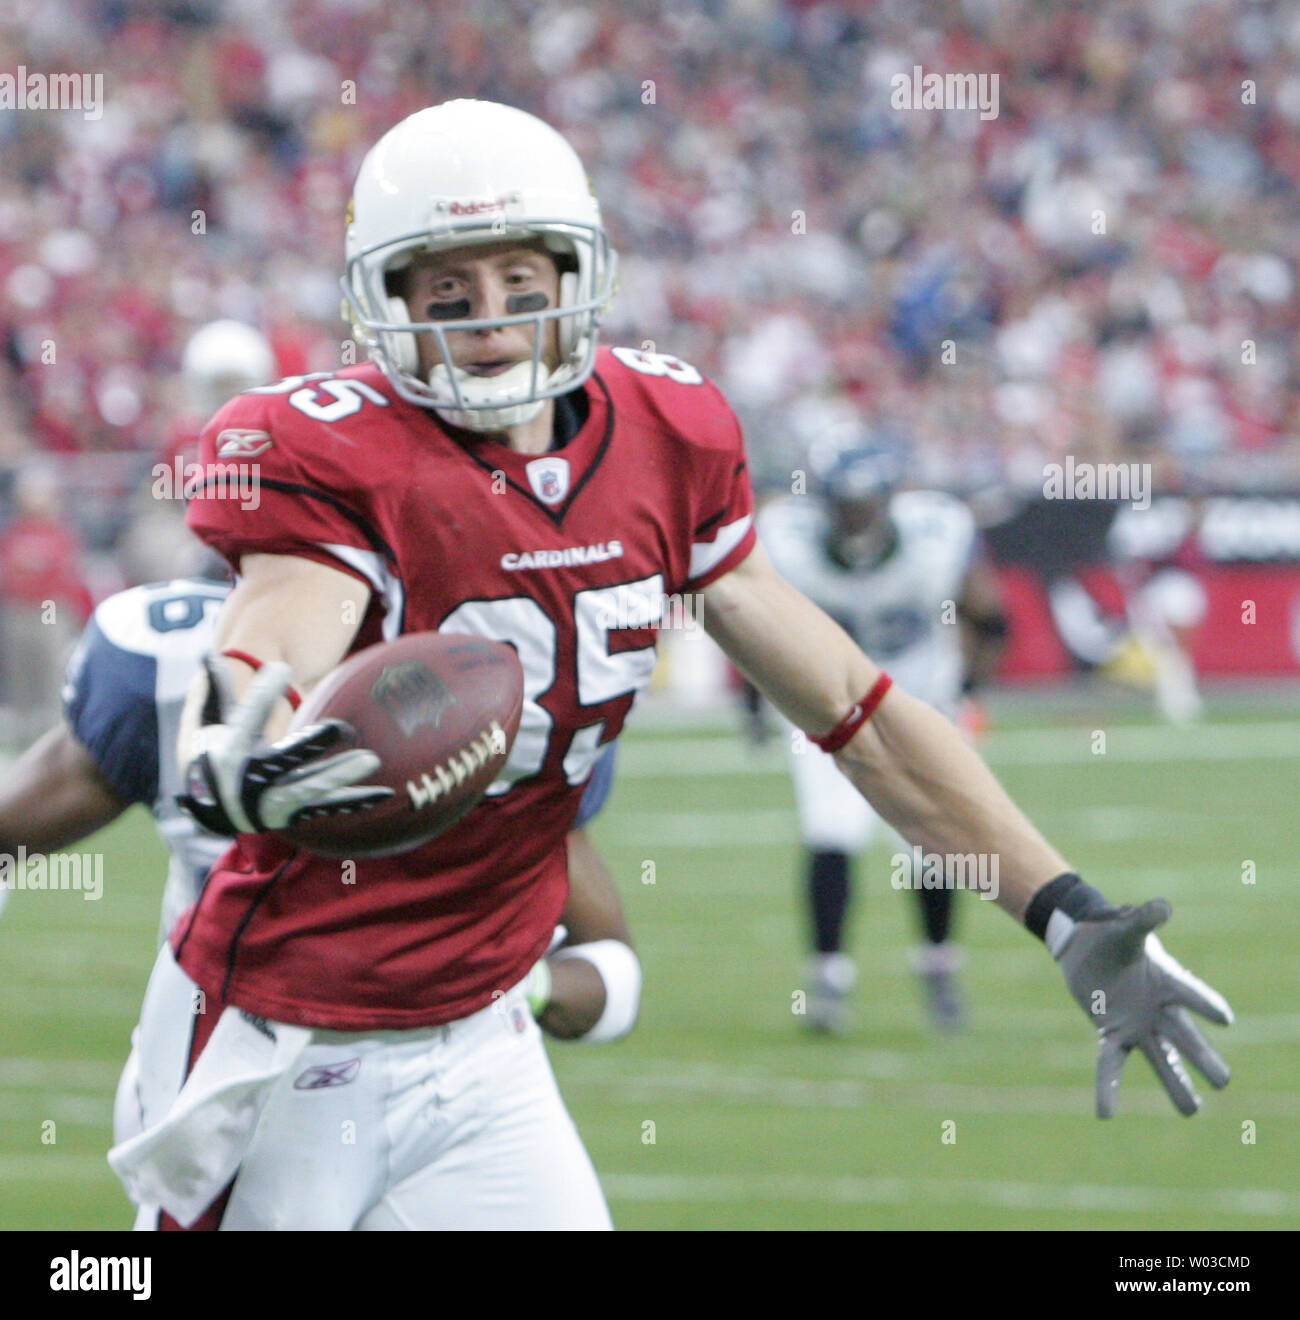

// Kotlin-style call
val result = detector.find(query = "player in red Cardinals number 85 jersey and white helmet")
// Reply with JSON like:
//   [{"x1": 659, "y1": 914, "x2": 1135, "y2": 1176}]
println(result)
[{"x1": 111, "y1": 102, "x2": 1230, "y2": 1229}]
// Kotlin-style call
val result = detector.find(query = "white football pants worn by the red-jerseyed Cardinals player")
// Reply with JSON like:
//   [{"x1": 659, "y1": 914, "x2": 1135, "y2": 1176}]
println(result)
[{"x1": 116, "y1": 945, "x2": 611, "y2": 1229}]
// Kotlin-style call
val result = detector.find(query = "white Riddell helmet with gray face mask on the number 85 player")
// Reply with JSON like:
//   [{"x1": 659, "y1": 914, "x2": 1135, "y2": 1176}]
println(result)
[{"x1": 342, "y1": 100, "x2": 618, "y2": 430}]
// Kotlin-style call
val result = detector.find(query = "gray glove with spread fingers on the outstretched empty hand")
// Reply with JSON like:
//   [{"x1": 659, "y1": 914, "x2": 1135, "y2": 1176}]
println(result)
[{"x1": 1047, "y1": 899, "x2": 1233, "y2": 1118}]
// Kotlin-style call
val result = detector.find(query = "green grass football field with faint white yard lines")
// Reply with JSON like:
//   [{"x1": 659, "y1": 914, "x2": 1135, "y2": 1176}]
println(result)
[{"x1": 0, "y1": 690, "x2": 1300, "y2": 1229}]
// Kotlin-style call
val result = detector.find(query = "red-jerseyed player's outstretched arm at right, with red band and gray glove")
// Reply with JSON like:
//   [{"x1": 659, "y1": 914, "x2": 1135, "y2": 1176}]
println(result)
[{"x1": 703, "y1": 546, "x2": 1233, "y2": 1118}]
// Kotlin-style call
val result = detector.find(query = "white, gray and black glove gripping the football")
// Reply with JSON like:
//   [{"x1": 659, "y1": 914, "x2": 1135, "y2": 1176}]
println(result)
[{"x1": 177, "y1": 656, "x2": 393, "y2": 834}]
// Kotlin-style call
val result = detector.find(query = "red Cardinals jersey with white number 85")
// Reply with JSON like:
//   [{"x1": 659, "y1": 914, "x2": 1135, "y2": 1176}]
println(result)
[{"x1": 172, "y1": 348, "x2": 754, "y2": 1031}]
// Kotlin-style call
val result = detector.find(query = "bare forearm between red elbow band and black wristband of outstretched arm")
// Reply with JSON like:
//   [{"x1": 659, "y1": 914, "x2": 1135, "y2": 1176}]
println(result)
[{"x1": 835, "y1": 686, "x2": 1069, "y2": 919}]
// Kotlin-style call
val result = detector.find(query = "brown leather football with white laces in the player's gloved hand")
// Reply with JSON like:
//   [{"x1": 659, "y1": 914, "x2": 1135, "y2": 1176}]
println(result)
[{"x1": 276, "y1": 632, "x2": 524, "y2": 858}]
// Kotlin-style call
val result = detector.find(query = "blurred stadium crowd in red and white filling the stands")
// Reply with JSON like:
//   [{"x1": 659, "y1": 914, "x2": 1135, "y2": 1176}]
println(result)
[{"x1": 0, "y1": 0, "x2": 1300, "y2": 615}]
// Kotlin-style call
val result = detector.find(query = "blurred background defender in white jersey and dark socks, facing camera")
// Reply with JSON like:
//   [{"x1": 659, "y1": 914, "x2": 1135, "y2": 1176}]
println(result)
[{"x1": 759, "y1": 449, "x2": 1007, "y2": 1031}]
